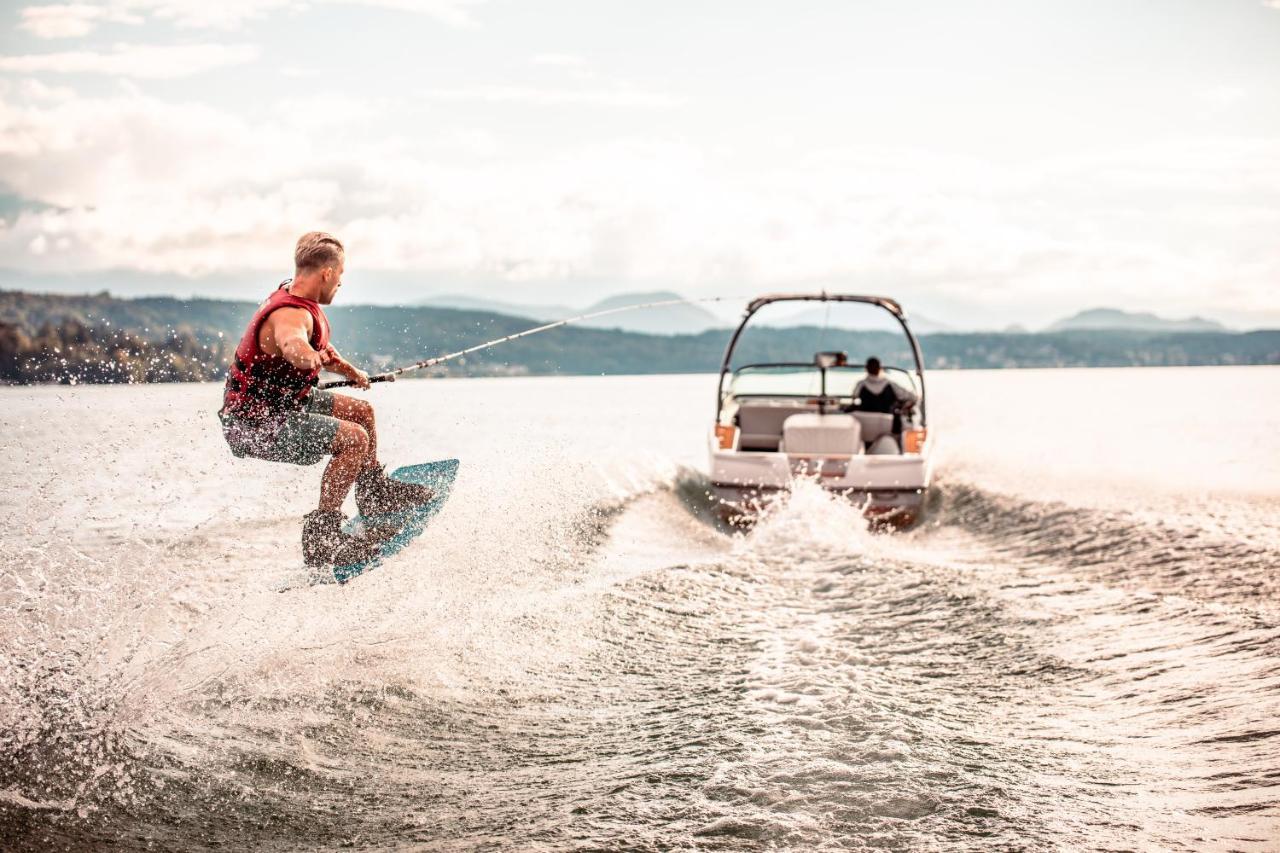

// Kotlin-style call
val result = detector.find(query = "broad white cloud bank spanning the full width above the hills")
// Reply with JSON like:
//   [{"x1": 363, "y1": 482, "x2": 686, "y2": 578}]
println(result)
[{"x1": 0, "y1": 85, "x2": 1280, "y2": 322}]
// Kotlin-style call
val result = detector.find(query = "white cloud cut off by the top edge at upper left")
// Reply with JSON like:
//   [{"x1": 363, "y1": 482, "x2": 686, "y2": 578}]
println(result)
[{"x1": 20, "y1": 0, "x2": 484, "y2": 38}]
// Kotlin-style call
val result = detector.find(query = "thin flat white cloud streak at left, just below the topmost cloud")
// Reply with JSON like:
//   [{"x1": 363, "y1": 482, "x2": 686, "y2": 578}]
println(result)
[{"x1": 0, "y1": 45, "x2": 259, "y2": 79}]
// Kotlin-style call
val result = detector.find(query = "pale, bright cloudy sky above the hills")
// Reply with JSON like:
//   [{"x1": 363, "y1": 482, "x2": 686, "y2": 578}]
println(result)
[{"x1": 0, "y1": 0, "x2": 1280, "y2": 328}]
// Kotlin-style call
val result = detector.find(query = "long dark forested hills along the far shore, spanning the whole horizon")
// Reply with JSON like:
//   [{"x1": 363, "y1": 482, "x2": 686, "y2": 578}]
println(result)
[{"x1": 0, "y1": 291, "x2": 1280, "y2": 383}]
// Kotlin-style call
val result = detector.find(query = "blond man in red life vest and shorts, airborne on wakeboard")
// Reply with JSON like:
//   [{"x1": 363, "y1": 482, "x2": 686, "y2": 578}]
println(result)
[{"x1": 218, "y1": 231, "x2": 433, "y2": 567}]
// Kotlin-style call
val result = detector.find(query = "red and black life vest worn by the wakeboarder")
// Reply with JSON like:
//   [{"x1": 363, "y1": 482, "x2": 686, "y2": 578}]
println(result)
[{"x1": 220, "y1": 280, "x2": 329, "y2": 419}]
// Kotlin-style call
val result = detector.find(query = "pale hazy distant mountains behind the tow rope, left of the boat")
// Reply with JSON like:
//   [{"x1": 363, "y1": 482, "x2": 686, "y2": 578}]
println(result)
[{"x1": 417, "y1": 291, "x2": 724, "y2": 334}]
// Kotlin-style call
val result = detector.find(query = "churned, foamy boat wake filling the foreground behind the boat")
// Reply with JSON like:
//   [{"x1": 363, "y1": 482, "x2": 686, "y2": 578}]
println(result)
[{"x1": 0, "y1": 445, "x2": 1280, "y2": 849}]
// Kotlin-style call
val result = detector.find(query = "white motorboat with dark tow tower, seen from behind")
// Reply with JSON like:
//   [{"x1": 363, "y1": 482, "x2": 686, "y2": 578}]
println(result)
[{"x1": 708, "y1": 293, "x2": 933, "y2": 528}]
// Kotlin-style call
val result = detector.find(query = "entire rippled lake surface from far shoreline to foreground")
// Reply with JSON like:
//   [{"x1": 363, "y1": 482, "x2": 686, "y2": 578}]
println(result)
[{"x1": 0, "y1": 368, "x2": 1280, "y2": 850}]
